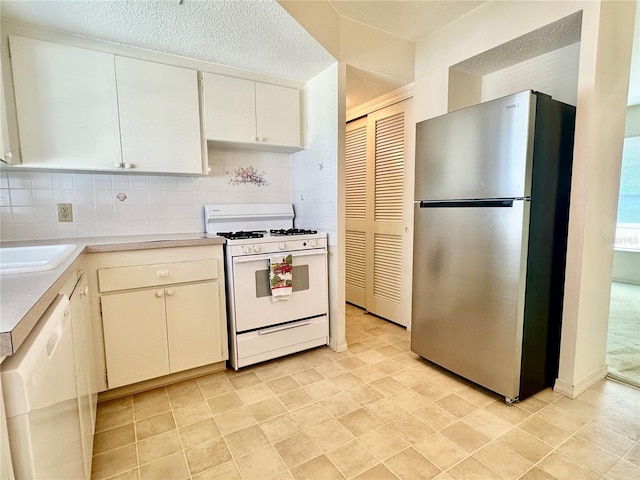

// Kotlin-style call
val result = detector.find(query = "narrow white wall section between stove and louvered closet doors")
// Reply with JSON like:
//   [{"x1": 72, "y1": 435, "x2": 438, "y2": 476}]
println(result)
[{"x1": 291, "y1": 63, "x2": 347, "y2": 351}]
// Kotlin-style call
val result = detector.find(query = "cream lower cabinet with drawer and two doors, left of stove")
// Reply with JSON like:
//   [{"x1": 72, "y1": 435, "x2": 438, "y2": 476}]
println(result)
[{"x1": 90, "y1": 246, "x2": 228, "y2": 389}]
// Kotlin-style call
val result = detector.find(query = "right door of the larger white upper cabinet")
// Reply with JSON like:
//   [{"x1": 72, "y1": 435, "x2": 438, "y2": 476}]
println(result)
[{"x1": 115, "y1": 56, "x2": 203, "y2": 174}]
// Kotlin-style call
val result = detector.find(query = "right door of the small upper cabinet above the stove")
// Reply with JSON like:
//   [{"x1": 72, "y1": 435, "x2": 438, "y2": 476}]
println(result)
[{"x1": 255, "y1": 83, "x2": 300, "y2": 147}]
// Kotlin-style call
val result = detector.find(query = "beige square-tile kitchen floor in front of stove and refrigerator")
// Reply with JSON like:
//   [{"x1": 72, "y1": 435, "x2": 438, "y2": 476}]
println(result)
[{"x1": 92, "y1": 306, "x2": 640, "y2": 480}]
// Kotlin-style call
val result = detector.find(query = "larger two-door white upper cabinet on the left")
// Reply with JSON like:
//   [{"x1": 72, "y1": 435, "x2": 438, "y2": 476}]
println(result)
[{"x1": 10, "y1": 36, "x2": 203, "y2": 174}]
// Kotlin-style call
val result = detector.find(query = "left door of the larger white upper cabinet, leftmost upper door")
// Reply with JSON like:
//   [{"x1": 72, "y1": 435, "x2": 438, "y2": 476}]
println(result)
[{"x1": 10, "y1": 36, "x2": 121, "y2": 170}]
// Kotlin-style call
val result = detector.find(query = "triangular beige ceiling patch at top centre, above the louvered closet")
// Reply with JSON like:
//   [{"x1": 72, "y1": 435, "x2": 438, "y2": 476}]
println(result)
[{"x1": 330, "y1": 0, "x2": 485, "y2": 42}]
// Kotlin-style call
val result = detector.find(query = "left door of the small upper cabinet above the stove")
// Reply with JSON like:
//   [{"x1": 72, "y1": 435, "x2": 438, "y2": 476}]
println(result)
[{"x1": 202, "y1": 73, "x2": 256, "y2": 143}]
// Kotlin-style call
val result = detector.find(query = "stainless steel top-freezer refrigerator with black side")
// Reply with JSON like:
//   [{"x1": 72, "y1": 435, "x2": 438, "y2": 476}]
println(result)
[{"x1": 411, "y1": 91, "x2": 575, "y2": 403}]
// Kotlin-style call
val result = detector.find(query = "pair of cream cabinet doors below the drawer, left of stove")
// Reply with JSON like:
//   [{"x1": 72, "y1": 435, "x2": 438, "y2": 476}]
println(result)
[{"x1": 102, "y1": 282, "x2": 225, "y2": 388}]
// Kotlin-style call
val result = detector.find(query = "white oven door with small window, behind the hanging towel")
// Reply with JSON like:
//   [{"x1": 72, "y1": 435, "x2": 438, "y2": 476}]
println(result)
[{"x1": 232, "y1": 249, "x2": 328, "y2": 333}]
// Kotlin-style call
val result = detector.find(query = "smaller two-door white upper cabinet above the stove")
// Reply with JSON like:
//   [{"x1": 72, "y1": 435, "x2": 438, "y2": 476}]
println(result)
[{"x1": 202, "y1": 73, "x2": 302, "y2": 152}]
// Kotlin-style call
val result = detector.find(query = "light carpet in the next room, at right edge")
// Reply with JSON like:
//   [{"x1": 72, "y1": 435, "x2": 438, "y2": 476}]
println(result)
[{"x1": 607, "y1": 282, "x2": 640, "y2": 387}]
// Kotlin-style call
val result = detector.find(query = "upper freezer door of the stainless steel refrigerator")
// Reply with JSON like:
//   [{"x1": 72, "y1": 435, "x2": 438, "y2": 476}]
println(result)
[{"x1": 415, "y1": 91, "x2": 537, "y2": 200}]
